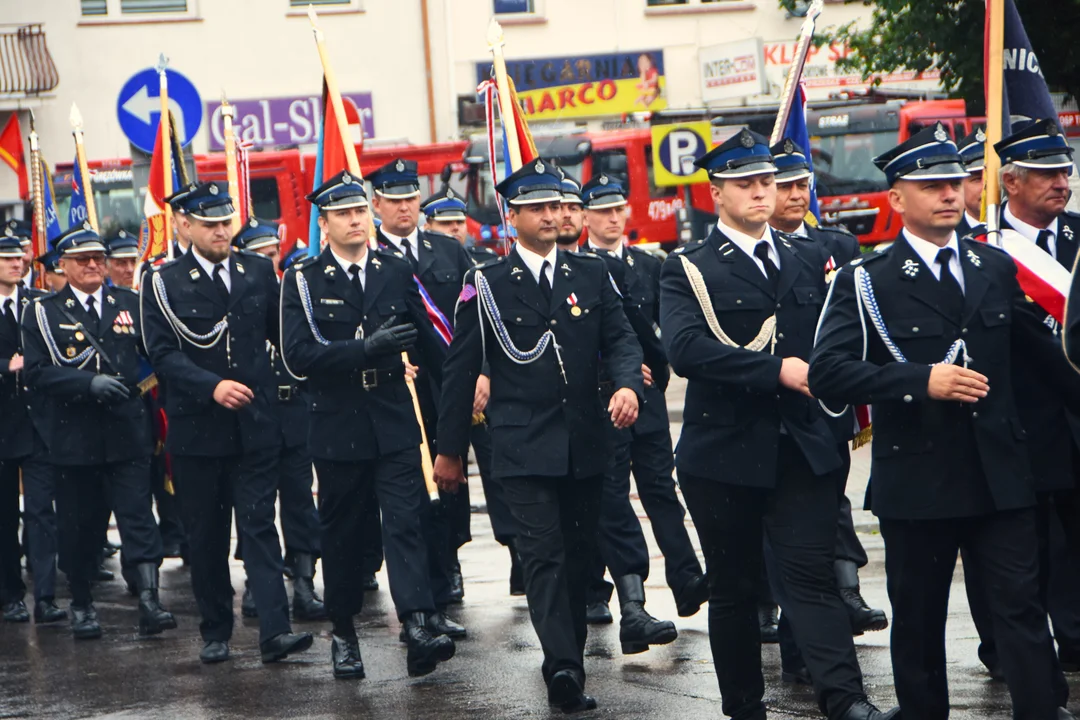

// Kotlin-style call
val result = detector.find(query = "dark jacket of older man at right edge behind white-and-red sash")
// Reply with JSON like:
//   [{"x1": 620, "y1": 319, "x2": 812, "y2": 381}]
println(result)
[{"x1": 1001, "y1": 205, "x2": 1080, "y2": 491}]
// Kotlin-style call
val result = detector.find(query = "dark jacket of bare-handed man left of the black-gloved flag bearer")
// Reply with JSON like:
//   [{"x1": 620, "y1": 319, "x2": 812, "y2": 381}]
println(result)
[{"x1": 141, "y1": 250, "x2": 281, "y2": 457}]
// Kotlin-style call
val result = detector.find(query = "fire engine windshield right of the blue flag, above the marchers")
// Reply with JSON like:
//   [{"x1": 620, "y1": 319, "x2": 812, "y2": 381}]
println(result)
[{"x1": 810, "y1": 131, "x2": 896, "y2": 198}]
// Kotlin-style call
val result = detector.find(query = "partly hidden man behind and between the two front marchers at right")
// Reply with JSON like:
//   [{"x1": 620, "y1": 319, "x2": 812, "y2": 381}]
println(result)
[{"x1": 766, "y1": 137, "x2": 889, "y2": 684}]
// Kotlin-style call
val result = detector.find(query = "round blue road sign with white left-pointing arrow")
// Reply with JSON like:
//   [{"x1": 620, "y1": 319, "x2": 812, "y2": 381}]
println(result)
[{"x1": 117, "y1": 68, "x2": 202, "y2": 153}]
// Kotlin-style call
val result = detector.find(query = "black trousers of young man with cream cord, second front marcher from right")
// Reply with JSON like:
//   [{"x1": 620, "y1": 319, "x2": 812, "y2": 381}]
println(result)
[{"x1": 679, "y1": 435, "x2": 865, "y2": 720}]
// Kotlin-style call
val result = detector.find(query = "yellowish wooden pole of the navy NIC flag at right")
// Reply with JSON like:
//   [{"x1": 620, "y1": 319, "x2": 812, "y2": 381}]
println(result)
[{"x1": 982, "y1": 0, "x2": 1005, "y2": 245}]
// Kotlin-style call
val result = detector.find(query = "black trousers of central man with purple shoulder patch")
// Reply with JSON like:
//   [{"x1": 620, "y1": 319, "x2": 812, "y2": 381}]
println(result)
[{"x1": 502, "y1": 475, "x2": 604, "y2": 683}]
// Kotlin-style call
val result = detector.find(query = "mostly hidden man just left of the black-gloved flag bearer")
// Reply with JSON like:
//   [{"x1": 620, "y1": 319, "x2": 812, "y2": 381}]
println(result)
[{"x1": 232, "y1": 217, "x2": 326, "y2": 621}]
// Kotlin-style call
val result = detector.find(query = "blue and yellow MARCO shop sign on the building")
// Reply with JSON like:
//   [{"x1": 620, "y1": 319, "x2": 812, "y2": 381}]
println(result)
[{"x1": 476, "y1": 50, "x2": 667, "y2": 120}]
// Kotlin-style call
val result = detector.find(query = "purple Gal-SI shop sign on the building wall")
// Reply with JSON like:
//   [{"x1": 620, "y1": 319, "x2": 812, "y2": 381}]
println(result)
[{"x1": 206, "y1": 93, "x2": 375, "y2": 152}]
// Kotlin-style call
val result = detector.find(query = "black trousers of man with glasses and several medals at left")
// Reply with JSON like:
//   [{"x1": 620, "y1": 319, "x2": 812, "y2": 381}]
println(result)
[{"x1": 56, "y1": 458, "x2": 161, "y2": 606}]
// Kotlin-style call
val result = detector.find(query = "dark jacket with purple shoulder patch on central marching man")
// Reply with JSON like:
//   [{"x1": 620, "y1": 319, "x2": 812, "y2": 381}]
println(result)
[{"x1": 438, "y1": 245, "x2": 644, "y2": 478}]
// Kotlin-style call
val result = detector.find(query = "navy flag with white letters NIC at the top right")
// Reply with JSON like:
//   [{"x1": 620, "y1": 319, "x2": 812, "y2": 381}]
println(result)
[{"x1": 1002, "y1": 0, "x2": 1057, "y2": 124}]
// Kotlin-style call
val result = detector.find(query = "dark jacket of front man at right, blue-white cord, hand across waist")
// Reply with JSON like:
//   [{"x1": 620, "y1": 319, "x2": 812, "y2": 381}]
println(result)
[{"x1": 810, "y1": 236, "x2": 1059, "y2": 519}]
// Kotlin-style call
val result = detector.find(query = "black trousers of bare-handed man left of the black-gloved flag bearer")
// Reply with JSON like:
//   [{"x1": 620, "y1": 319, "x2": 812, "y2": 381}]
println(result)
[{"x1": 173, "y1": 447, "x2": 291, "y2": 642}]
